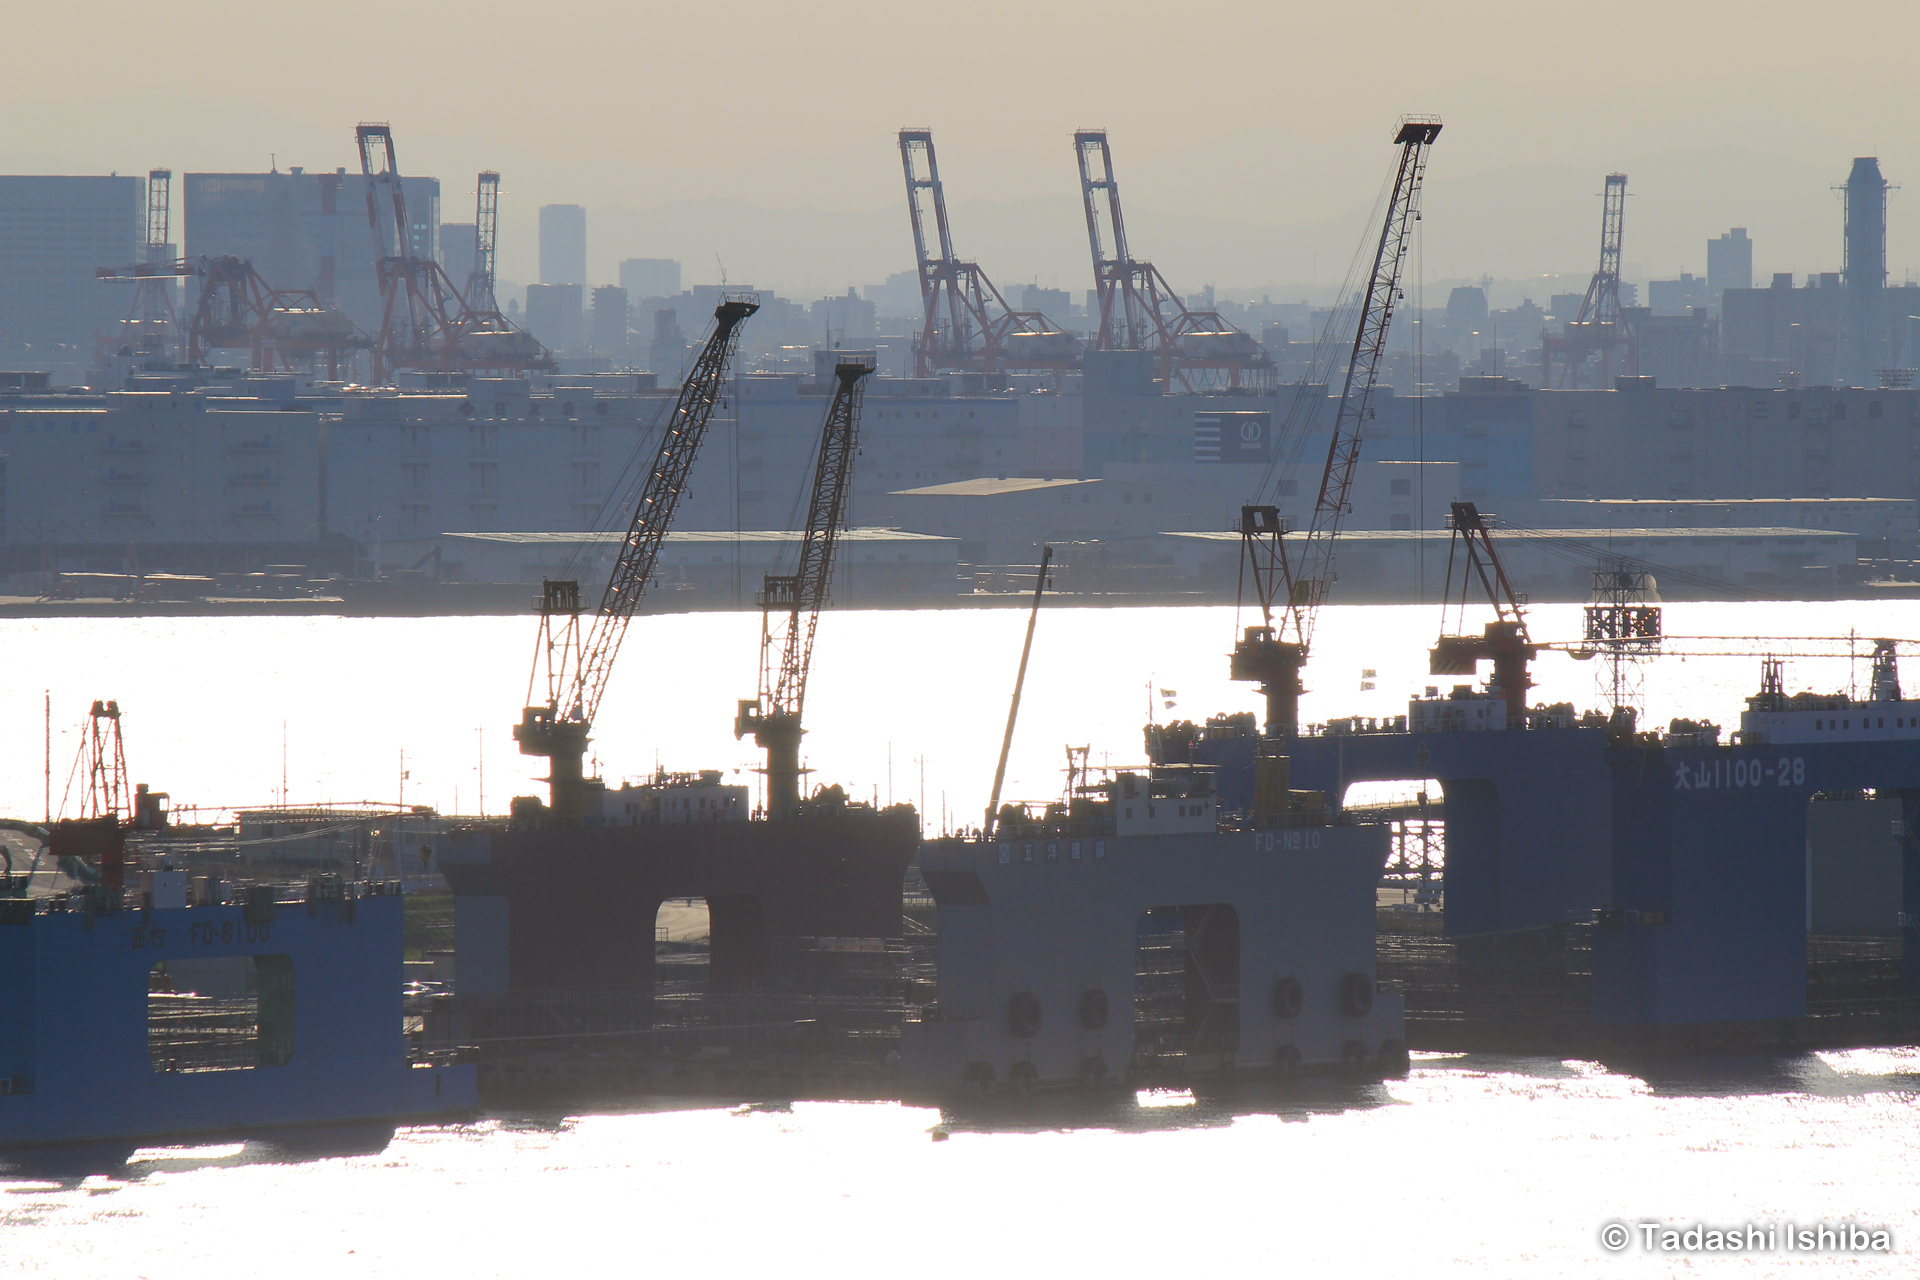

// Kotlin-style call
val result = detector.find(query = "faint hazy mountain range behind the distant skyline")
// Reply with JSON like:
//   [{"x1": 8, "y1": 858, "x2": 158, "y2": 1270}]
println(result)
[{"x1": 487, "y1": 148, "x2": 1896, "y2": 305}]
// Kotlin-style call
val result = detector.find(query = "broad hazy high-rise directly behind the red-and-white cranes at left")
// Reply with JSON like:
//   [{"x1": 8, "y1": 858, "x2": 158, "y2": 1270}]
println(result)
[{"x1": 182, "y1": 167, "x2": 440, "y2": 332}]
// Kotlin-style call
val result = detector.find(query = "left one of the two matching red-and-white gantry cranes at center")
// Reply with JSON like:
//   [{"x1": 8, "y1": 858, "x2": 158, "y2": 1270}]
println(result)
[{"x1": 900, "y1": 129, "x2": 1079, "y2": 378}]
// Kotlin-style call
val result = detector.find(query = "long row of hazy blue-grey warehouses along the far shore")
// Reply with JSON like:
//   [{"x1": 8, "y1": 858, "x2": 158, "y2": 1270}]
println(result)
[{"x1": 0, "y1": 351, "x2": 1920, "y2": 593}]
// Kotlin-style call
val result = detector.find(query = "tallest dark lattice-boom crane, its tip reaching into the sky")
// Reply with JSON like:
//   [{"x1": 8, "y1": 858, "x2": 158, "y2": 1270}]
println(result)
[{"x1": 1231, "y1": 117, "x2": 1440, "y2": 739}]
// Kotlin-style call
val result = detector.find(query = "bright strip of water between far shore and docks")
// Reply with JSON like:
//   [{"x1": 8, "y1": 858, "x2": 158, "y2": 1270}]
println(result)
[{"x1": 0, "y1": 603, "x2": 1920, "y2": 827}]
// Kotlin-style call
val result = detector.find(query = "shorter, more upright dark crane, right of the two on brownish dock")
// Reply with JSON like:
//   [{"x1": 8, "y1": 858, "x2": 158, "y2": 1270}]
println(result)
[{"x1": 733, "y1": 363, "x2": 874, "y2": 818}]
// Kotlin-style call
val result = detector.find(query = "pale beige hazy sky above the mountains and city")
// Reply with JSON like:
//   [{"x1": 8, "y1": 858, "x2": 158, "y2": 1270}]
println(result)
[{"x1": 15, "y1": 0, "x2": 1920, "y2": 291}]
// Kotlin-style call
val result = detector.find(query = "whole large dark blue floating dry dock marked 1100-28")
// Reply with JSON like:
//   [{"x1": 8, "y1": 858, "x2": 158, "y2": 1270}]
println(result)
[{"x1": 1162, "y1": 654, "x2": 1920, "y2": 1052}]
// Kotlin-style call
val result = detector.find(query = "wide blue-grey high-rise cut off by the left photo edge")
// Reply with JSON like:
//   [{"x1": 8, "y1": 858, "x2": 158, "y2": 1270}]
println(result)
[{"x1": 0, "y1": 177, "x2": 146, "y2": 368}]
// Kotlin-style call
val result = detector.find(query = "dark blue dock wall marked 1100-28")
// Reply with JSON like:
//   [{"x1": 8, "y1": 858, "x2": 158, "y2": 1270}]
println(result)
[{"x1": 1196, "y1": 727, "x2": 1920, "y2": 1048}]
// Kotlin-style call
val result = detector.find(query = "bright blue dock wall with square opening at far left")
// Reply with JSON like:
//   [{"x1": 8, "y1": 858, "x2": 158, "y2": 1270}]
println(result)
[{"x1": 0, "y1": 894, "x2": 474, "y2": 1148}]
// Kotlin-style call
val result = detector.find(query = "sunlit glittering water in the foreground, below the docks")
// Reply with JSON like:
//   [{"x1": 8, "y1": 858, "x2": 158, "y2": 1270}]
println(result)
[{"x1": 0, "y1": 1050, "x2": 1920, "y2": 1278}]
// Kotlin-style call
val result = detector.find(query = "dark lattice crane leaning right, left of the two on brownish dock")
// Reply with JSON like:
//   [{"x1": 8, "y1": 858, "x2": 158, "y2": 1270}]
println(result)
[{"x1": 513, "y1": 294, "x2": 760, "y2": 821}]
